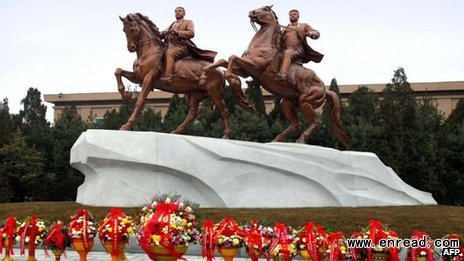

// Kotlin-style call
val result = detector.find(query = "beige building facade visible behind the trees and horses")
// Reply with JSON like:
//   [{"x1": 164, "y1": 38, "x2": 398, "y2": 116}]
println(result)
[{"x1": 44, "y1": 81, "x2": 464, "y2": 120}]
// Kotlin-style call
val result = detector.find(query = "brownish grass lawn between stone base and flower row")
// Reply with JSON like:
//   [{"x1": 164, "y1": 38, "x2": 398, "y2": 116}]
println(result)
[{"x1": 0, "y1": 202, "x2": 464, "y2": 238}]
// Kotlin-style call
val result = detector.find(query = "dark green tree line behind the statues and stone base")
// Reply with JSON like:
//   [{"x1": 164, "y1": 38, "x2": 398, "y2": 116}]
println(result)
[{"x1": 0, "y1": 68, "x2": 464, "y2": 205}]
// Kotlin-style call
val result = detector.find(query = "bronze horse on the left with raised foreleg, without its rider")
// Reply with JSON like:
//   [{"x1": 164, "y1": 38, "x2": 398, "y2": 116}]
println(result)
[{"x1": 115, "y1": 13, "x2": 255, "y2": 138}]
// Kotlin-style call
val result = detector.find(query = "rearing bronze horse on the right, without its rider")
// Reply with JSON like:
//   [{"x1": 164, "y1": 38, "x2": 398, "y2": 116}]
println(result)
[{"x1": 201, "y1": 6, "x2": 350, "y2": 146}]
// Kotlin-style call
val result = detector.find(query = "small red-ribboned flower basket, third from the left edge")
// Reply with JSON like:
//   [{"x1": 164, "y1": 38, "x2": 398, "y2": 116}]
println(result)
[{"x1": 43, "y1": 221, "x2": 70, "y2": 261}]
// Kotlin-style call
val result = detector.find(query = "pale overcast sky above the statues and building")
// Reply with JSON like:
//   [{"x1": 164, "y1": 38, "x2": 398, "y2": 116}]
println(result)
[{"x1": 0, "y1": 0, "x2": 464, "y2": 120}]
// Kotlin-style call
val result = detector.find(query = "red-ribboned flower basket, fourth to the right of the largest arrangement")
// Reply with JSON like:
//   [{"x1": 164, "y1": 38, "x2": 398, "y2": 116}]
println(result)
[{"x1": 269, "y1": 223, "x2": 298, "y2": 261}]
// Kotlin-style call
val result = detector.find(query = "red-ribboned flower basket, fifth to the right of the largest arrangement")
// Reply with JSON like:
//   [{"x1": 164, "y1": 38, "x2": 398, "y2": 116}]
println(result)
[{"x1": 295, "y1": 222, "x2": 329, "y2": 261}]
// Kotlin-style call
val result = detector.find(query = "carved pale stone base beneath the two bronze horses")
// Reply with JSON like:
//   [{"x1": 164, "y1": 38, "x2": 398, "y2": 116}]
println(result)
[{"x1": 71, "y1": 130, "x2": 436, "y2": 208}]
